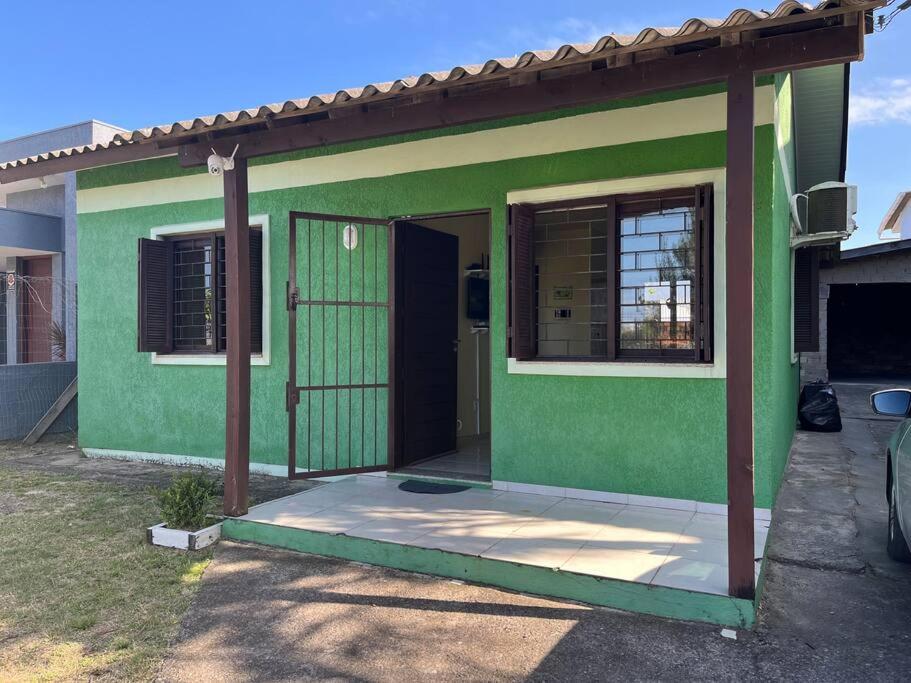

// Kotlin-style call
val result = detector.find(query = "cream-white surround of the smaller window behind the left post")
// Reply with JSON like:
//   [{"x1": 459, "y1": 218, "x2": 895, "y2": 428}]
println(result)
[{"x1": 149, "y1": 214, "x2": 272, "y2": 366}]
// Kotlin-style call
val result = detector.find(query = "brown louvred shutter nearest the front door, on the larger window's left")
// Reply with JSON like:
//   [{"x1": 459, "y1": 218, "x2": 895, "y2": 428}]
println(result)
[{"x1": 506, "y1": 204, "x2": 537, "y2": 360}]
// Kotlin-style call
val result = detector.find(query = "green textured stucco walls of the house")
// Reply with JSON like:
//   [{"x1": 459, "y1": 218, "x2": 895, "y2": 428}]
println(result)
[{"x1": 78, "y1": 81, "x2": 794, "y2": 507}]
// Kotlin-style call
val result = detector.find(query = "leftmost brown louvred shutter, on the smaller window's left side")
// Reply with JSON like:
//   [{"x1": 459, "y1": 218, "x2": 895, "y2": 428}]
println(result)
[{"x1": 138, "y1": 239, "x2": 174, "y2": 353}]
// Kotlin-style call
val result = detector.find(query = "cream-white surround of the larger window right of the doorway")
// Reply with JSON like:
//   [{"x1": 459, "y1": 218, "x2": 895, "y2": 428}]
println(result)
[{"x1": 506, "y1": 168, "x2": 727, "y2": 379}]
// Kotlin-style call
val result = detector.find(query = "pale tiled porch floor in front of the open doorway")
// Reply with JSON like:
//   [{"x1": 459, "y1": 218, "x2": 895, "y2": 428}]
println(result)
[{"x1": 241, "y1": 475, "x2": 769, "y2": 595}]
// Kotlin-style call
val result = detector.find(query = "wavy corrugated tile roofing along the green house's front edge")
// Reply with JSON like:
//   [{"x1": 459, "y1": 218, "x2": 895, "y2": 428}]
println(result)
[{"x1": 0, "y1": 0, "x2": 881, "y2": 176}]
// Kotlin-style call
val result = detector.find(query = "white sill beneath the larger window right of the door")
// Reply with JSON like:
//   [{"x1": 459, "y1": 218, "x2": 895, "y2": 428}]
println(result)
[{"x1": 506, "y1": 358, "x2": 726, "y2": 379}]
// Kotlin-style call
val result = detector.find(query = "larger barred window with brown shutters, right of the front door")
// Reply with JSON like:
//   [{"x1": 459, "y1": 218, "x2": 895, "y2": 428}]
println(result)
[{"x1": 508, "y1": 185, "x2": 714, "y2": 362}]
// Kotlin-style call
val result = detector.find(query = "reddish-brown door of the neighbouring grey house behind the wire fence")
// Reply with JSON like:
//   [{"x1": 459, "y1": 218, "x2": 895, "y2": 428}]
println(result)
[{"x1": 17, "y1": 256, "x2": 53, "y2": 363}]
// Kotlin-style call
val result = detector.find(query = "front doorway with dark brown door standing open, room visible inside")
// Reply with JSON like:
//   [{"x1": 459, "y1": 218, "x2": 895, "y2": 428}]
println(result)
[{"x1": 393, "y1": 212, "x2": 491, "y2": 481}]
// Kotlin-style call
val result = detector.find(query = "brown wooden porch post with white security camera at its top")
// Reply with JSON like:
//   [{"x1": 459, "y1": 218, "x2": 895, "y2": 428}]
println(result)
[{"x1": 224, "y1": 158, "x2": 250, "y2": 517}]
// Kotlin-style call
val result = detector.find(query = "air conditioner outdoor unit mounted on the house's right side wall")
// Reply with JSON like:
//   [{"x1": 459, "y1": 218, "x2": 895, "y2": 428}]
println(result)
[{"x1": 791, "y1": 182, "x2": 857, "y2": 249}]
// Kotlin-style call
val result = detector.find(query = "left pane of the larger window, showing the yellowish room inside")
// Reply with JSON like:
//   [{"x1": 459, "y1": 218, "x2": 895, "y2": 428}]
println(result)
[{"x1": 535, "y1": 206, "x2": 609, "y2": 357}]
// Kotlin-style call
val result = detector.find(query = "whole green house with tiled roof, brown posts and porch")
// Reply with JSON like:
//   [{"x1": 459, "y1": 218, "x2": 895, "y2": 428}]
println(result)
[{"x1": 0, "y1": 0, "x2": 870, "y2": 624}]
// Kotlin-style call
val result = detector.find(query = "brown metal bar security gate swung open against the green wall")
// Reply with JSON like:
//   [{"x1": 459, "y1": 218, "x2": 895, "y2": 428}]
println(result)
[{"x1": 286, "y1": 211, "x2": 394, "y2": 479}]
